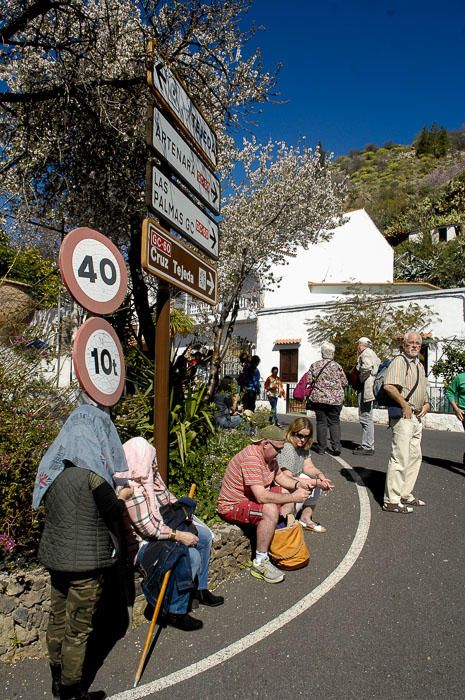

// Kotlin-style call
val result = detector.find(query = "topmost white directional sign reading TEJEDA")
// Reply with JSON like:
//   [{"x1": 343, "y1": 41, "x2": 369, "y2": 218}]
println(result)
[{"x1": 148, "y1": 44, "x2": 216, "y2": 168}]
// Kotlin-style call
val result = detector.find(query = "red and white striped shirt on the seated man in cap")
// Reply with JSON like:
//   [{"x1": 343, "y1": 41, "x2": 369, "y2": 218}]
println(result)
[{"x1": 218, "y1": 443, "x2": 280, "y2": 515}]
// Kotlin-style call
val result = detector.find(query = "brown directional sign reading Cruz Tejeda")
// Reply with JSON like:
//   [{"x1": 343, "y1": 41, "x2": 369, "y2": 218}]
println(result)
[{"x1": 142, "y1": 219, "x2": 217, "y2": 306}]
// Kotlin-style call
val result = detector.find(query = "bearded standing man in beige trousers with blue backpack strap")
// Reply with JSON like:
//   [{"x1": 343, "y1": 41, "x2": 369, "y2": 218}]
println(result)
[{"x1": 383, "y1": 331, "x2": 430, "y2": 514}]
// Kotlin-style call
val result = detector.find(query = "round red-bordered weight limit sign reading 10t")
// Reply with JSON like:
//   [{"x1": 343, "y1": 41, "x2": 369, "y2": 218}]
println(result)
[{"x1": 73, "y1": 318, "x2": 125, "y2": 406}]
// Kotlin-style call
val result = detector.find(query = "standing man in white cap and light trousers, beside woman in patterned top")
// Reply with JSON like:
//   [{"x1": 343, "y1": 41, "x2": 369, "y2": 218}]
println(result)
[{"x1": 353, "y1": 336, "x2": 380, "y2": 456}]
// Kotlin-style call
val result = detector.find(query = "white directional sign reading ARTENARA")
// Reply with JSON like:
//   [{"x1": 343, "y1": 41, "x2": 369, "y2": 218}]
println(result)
[{"x1": 151, "y1": 107, "x2": 220, "y2": 214}]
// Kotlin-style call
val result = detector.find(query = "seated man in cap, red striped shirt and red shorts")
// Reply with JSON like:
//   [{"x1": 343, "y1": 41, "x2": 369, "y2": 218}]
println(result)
[{"x1": 218, "y1": 425, "x2": 310, "y2": 583}]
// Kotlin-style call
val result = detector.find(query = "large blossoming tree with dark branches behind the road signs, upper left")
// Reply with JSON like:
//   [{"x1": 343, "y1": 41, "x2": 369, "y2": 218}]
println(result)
[{"x1": 0, "y1": 0, "x2": 275, "y2": 346}]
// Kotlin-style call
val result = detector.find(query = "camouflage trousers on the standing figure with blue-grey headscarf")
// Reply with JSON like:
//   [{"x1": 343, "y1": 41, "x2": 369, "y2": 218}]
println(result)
[{"x1": 47, "y1": 571, "x2": 103, "y2": 685}]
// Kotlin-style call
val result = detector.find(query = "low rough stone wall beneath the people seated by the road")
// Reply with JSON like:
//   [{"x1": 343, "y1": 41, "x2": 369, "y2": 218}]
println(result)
[{"x1": 0, "y1": 523, "x2": 251, "y2": 662}]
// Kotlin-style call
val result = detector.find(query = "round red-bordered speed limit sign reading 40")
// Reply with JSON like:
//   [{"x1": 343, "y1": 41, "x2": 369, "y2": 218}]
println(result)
[{"x1": 58, "y1": 227, "x2": 128, "y2": 314}]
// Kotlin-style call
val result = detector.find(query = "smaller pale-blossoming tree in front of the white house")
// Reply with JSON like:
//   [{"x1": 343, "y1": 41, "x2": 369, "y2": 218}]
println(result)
[{"x1": 199, "y1": 140, "x2": 345, "y2": 395}]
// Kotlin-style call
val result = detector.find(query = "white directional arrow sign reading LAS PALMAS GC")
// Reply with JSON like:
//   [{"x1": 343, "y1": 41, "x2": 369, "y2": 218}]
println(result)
[{"x1": 147, "y1": 165, "x2": 218, "y2": 259}]
